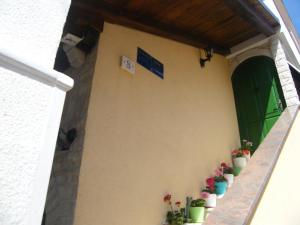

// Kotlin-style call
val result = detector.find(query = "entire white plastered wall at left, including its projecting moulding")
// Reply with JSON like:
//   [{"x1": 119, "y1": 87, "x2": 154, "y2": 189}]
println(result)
[{"x1": 0, "y1": 0, "x2": 73, "y2": 225}]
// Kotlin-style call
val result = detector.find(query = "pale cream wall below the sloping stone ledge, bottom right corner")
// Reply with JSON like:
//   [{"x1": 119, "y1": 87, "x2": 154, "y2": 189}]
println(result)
[{"x1": 250, "y1": 107, "x2": 300, "y2": 225}]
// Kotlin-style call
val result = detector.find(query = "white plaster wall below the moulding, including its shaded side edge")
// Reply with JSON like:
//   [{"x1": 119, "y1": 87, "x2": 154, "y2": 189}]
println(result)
[{"x1": 0, "y1": 63, "x2": 71, "y2": 225}]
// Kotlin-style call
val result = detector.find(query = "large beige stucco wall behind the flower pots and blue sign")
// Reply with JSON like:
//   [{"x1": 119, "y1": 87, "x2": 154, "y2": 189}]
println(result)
[{"x1": 75, "y1": 23, "x2": 239, "y2": 225}]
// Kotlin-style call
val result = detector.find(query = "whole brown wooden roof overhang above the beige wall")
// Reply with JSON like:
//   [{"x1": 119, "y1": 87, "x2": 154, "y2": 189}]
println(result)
[{"x1": 69, "y1": 0, "x2": 280, "y2": 55}]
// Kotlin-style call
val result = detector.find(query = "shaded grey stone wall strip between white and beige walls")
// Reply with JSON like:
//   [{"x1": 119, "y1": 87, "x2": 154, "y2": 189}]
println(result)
[{"x1": 45, "y1": 48, "x2": 97, "y2": 225}]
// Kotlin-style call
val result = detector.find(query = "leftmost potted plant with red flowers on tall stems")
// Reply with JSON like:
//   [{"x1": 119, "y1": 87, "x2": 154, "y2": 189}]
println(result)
[{"x1": 164, "y1": 194, "x2": 185, "y2": 225}]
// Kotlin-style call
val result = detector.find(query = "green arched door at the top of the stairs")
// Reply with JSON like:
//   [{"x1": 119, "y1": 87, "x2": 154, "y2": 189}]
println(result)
[{"x1": 232, "y1": 56, "x2": 285, "y2": 150}]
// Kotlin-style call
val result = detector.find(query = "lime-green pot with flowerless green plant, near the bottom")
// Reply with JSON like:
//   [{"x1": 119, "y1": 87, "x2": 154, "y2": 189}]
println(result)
[{"x1": 189, "y1": 199, "x2": 205, "y2": 223}]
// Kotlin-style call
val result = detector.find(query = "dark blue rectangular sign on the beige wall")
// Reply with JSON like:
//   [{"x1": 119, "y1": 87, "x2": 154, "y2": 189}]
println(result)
[{"x1": 137, "y1": 48, "x2": 164, "y2": 79}]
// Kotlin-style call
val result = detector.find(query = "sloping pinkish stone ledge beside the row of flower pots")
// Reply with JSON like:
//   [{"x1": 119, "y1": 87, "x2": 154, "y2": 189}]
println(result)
[{"x1": 203, "y1": 106, "x2": 299, "y2": 225}]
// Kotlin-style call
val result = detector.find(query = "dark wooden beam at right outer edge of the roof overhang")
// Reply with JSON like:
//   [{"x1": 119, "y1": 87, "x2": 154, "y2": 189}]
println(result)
[{"x1": 224, "y1": 0, "x2": 276, "y2": 36}]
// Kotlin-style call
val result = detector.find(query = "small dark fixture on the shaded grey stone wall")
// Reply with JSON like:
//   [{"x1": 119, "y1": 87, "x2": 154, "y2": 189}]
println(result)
[{"x1": 57, "y1": 128, "x2": 77, "y2": 151}]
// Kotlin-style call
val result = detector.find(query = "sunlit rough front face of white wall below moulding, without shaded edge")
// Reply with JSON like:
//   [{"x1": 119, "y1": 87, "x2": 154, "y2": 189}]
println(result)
[{"x1": 0, "y1": 68, "x2": 51, "y2": 225}]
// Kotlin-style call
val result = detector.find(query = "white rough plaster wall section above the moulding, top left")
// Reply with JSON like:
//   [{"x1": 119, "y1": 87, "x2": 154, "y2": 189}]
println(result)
[{"x1": 0, "y1": 0, "x2": 71, "y2": 68}]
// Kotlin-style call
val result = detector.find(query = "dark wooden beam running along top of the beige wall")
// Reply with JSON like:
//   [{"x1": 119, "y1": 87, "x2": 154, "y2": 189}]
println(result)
[{"x1": 72, "y1": 0, "x2": 230, "y2": 55}]
